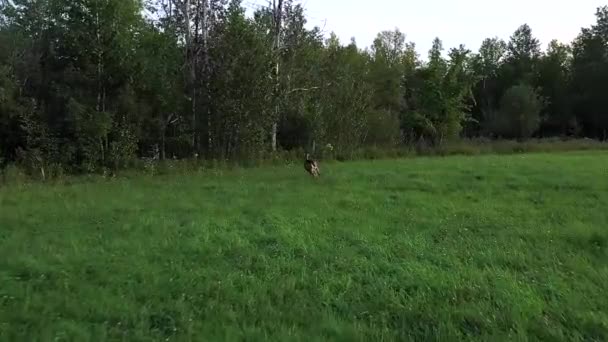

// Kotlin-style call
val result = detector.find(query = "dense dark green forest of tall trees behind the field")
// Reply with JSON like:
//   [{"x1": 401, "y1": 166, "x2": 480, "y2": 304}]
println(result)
[{"x1": 0, "y1": 0, "x2": 608, "y2": 173}]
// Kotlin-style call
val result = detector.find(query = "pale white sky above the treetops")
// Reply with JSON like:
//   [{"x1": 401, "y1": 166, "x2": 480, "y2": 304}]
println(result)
[{"x1": 244, "y1": 0, "x2": 608, "y2": 57}]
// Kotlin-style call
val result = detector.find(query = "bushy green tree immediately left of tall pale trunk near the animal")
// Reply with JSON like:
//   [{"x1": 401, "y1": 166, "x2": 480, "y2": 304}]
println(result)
[{"x1": 208, "y1": 6, "x2": 273, "y2": 159}]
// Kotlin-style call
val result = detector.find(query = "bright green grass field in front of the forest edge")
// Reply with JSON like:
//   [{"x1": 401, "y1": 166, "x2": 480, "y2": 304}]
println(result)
[{"x1": 0, "y1": 152, "x2": 608, "y2": 341}]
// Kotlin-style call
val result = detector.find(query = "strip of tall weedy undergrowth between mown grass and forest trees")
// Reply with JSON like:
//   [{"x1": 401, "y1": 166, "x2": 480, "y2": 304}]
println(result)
[{"x1": 0, "y1": 138, "x2": 608, "y2": 184}]
